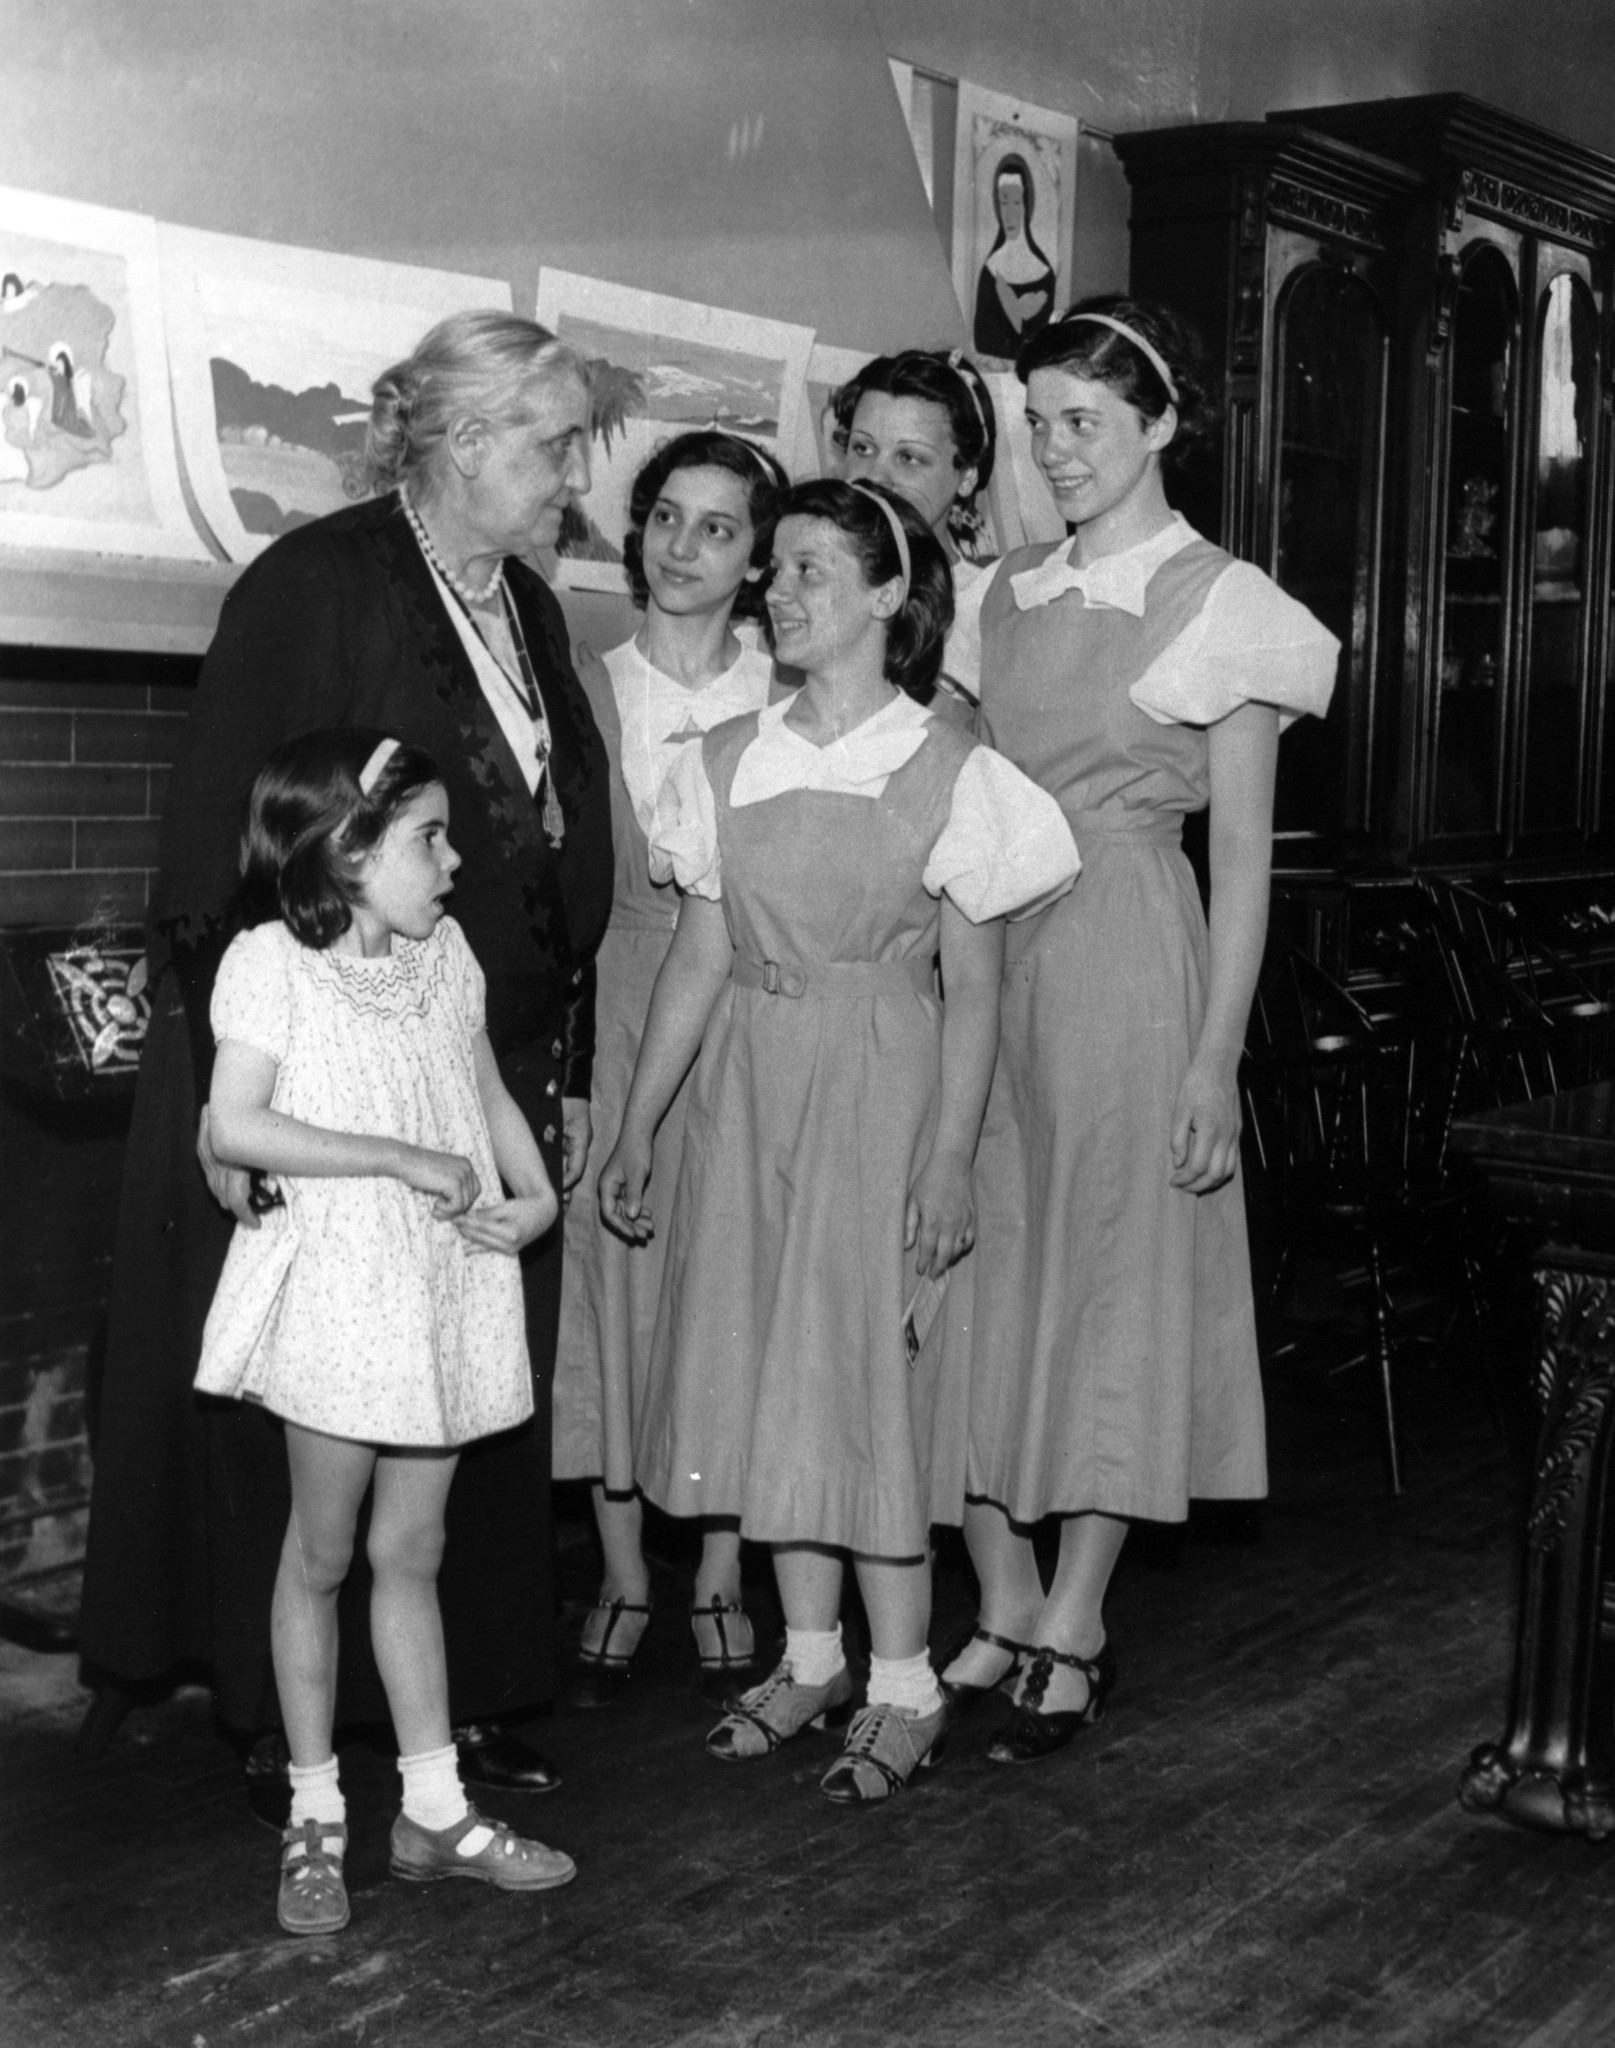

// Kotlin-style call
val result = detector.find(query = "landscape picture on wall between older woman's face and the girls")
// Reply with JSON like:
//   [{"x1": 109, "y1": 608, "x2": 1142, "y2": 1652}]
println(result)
[{"x1": 538, "y1": 270, "x2": 818, "y2": 590}]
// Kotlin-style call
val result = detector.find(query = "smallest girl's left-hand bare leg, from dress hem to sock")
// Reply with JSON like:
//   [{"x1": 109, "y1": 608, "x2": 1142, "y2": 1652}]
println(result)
[{"x1": 270, "y1": 1421, "x2": 377, "y2": 1769}]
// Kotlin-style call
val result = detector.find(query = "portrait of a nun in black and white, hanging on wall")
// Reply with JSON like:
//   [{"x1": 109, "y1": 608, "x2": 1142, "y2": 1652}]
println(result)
[{"x1": 954, "y1": 80, "x2": 1077, "y2": 367}]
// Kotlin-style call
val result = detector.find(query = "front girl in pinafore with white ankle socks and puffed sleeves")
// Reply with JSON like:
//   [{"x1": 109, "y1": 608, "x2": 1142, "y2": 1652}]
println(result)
[{"x1": 600, "y1": 481, "x2": 1077, "y2": 1802}]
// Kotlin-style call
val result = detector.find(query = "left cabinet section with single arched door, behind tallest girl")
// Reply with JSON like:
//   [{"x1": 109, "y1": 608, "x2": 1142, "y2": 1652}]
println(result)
[{"x1": 1116, "y1": 121, "x2": 1418, "y2": 870}]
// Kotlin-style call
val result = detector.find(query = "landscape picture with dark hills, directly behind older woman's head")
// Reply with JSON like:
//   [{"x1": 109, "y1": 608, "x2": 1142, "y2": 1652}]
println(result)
[{"x1": 158, "y1": 225, "x2": 510, "y2": 561}]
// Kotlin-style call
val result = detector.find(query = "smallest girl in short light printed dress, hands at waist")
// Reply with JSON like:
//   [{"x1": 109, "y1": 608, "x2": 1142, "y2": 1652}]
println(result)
[{"x1": 197, "y1": 729, "x2": 575, "y2": 1933}]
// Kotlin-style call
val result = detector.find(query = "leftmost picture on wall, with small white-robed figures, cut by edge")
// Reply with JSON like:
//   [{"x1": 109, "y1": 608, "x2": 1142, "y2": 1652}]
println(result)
[{"x1": 0, "y1": 188, "x2": 209, "y2": 561}]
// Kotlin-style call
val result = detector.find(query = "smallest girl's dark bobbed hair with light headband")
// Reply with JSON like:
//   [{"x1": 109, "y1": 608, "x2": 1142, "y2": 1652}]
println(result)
[{"x1": 237, "y1": 725, "x2": 442, "y2": 952}]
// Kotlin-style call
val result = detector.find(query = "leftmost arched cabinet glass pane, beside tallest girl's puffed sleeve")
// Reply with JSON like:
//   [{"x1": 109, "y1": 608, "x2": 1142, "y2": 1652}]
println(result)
[{"x1": 1273, "y1": 262, "x2": 1386, "y2": 840}]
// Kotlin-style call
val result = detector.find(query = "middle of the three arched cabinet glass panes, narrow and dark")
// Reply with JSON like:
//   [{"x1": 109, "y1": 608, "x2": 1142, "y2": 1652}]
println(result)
[{"x1": 1435, "y1": 242, "x2": 1519, "y2": 838}]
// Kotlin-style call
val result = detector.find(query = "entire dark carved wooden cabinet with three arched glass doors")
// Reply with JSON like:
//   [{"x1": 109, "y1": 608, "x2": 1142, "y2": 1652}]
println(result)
[{"x1": 1118, "y1": 94, "x2": 1615, "y2": 872}]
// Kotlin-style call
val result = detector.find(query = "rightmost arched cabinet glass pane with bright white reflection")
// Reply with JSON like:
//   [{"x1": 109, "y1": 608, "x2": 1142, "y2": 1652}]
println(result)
[{"x1": 1519, "y1": 272, "x2": 1599, "y2": 831}]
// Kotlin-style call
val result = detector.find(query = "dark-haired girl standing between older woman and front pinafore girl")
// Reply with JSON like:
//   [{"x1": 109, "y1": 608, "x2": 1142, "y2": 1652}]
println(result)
[{"x1": 555, "y1": 428, "x2": 788, "y2": 1706}]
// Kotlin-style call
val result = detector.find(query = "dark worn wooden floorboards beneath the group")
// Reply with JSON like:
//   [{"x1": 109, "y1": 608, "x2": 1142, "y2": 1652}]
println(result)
[{"x1": 0, "y1": 1343, "x2": 1615, "y2": 2048}]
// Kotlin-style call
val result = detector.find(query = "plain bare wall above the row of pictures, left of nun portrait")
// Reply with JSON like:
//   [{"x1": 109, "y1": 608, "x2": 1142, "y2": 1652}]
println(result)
[{"x1": 0, "y1": 0, "x2": 960, "y2": 348}]
